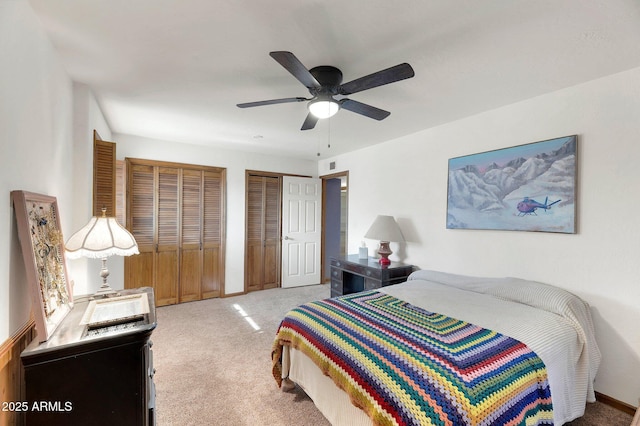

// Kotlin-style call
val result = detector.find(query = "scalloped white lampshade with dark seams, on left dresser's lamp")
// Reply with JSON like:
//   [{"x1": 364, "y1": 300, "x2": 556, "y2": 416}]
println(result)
[{"x1": 65, "y1": 216, "x2": 140, "y2": 259}]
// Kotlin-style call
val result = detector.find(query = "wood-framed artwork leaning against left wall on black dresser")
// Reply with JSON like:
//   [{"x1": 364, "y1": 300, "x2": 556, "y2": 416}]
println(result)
[{"x1": 11, "y1": 191, "x2": 73, "y2": 342}]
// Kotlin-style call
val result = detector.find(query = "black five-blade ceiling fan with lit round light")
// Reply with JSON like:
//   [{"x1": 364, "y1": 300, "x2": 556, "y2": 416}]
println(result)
[{"x1": 237, "y1": 51, "x2": 415, "y2": 130}]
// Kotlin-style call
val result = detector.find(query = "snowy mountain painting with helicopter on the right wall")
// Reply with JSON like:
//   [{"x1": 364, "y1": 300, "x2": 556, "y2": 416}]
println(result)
[{"x1": 447, "y1": 135, "x2": 577, "y2": 234}]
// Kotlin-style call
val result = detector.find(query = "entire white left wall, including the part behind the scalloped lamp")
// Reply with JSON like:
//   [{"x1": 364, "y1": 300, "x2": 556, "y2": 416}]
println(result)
[{"x1": 0, "y1": 0, "x2": 112, "y2": 342}]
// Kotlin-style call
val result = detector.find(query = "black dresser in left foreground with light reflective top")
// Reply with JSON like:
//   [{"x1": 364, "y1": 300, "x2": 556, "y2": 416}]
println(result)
[{"x1": 21, "y1": 287, "x2": 156, "y2": 426}]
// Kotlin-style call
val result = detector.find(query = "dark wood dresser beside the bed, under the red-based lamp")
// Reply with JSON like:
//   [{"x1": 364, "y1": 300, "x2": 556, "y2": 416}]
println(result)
[{"x1": 331, "y1": 254, "x2": 413, "y2": 297}]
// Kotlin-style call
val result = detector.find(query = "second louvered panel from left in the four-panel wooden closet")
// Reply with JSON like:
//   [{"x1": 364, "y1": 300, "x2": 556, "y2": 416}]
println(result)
[{"x1": 157, "y1": 167, "x2": 179, "y2": 306}]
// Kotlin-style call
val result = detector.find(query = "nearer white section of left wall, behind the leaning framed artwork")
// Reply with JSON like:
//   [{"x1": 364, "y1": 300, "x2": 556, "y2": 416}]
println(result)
[{"x1": 0, "y1": 0, "x2": 73, "y2": 343}]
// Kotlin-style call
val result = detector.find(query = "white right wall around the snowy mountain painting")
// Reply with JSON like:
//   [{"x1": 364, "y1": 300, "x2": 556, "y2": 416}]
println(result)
[{"x1": 318, "y1": 68, "x2": 640, "y2": 406}]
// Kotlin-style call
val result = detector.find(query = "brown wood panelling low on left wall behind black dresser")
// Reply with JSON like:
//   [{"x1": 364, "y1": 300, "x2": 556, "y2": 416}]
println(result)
[{"x1": 0, "y1": 319, "x2": 36, "y2": 425}]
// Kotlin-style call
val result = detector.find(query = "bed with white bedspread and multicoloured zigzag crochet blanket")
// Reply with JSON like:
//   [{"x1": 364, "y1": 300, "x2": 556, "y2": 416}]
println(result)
[{"x1": 272, "y1": 271, "x2": 600, "y2": 426}]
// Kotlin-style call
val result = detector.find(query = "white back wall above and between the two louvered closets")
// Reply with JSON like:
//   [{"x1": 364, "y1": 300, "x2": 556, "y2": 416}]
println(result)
[{"x1": 110, "y1": 134, "x2": 317, "y2": 294}]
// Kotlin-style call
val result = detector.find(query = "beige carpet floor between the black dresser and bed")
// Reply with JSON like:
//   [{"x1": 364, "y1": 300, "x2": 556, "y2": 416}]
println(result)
[{"x1": 151, "y1": 285, "x2": 632, "y2": 426}]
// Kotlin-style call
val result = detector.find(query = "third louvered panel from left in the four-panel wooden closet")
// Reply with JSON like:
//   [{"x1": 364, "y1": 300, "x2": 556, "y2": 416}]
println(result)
[{"x1": 180, "y1": 170, "x2": 202, "y2": 302}]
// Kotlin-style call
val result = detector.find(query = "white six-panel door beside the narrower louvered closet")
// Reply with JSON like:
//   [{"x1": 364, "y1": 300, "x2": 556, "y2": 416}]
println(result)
[{"x1": 282, "y1": 176, "x2": 322, "y2": 287}]
